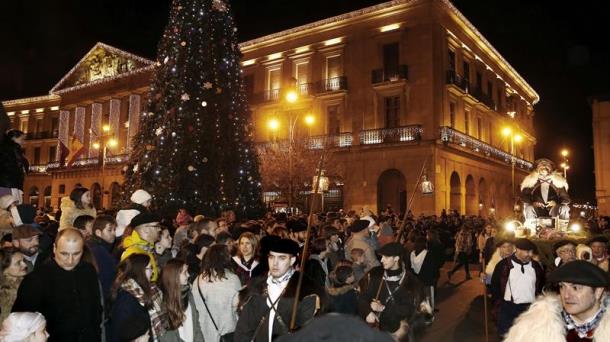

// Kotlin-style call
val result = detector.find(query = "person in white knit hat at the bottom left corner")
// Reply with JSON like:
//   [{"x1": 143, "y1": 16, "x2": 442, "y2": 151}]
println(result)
[{"x1": 0, "y1": 312, "x2": 49, "y2": 342}]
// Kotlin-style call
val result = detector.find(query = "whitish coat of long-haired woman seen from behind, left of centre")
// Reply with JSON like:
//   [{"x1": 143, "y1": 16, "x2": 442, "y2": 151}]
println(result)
[{"x1": 191, "y1": 269, "x2": 241, "y2": 342}]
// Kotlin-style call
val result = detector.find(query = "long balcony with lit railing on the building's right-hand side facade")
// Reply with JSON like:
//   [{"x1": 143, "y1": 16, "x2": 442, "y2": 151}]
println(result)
[{"x1": 440, "y1": 126, "x2": 534, "y2": 171}]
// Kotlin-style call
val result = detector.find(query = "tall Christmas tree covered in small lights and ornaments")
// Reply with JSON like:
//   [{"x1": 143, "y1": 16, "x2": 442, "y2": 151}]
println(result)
[{"x1": 125, "y1": 0, "x2": 262, "y2": 216}]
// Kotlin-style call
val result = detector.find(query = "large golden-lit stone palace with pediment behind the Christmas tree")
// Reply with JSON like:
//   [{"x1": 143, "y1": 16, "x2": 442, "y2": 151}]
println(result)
[{"x1": 4, "y1": 0, "x2": 539, "y2": 215}]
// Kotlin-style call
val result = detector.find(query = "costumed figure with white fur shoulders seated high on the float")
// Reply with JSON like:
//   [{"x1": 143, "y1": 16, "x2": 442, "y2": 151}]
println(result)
[{"x1": 521, "y1": 158, "x2": 570, "y2": 227}]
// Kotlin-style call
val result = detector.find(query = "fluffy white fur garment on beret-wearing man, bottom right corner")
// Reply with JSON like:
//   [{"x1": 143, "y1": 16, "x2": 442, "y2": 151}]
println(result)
[{"x1": 504, "y1": 293, "x2": 610, "y2": 342}]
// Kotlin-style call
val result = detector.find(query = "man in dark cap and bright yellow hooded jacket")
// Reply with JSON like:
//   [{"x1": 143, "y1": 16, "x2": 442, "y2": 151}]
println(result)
[{"x1": 121, "y1": 213, "x2": 161, "y2": 282}]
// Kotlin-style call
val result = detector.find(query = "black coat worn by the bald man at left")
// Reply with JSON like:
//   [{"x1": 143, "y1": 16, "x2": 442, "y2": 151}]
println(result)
[{"x1": 12, "y1": 259, "x2": 102, "y2": 342}]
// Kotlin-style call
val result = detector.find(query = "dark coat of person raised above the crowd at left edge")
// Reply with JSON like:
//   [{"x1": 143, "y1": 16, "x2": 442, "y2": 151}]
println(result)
[{"x1": 0, "y1": 139, "x2": 30, "y2": 191}]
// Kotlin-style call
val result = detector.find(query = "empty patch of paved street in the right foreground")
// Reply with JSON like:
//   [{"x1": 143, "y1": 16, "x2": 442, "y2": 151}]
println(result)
[{"x1": 421, "y1": 262, "x2": 499, "y2": 342}]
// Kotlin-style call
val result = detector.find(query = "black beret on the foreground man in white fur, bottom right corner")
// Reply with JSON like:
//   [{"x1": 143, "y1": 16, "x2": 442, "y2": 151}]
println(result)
[{"x1": 548, "y1": 260, "x2": 610, "y2": 287}]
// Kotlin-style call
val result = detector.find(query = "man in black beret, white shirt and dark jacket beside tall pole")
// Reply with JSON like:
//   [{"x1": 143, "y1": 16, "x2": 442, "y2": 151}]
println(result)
[{"x1": 234, "y1": 239, "x2": 323, "y2": 342}]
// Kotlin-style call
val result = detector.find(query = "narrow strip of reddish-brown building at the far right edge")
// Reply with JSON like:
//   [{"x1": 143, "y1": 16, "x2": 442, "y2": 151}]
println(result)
[{"x1": 591, "y1": 96, "x2": 610, "y2": 215}]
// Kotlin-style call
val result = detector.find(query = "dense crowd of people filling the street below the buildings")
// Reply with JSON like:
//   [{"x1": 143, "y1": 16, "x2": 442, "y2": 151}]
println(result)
[{"x1": 0, "y1": 180, "x2": 610, "y2": 341}]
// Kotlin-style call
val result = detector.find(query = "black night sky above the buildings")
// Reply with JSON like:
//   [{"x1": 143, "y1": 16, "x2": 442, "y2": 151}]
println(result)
[{"x1": 0, "y1": 0, "x2": 610, "y2": 200}]
